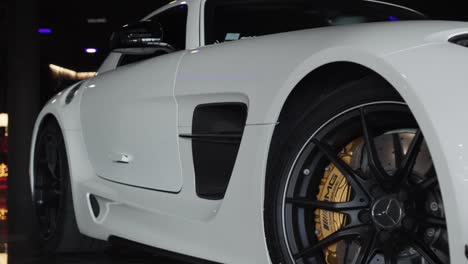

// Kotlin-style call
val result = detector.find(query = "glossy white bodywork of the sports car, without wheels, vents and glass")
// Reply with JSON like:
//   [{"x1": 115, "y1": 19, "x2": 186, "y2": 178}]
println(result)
[{"x1": 31, "y1": 1, "x2": 468, "y2": 263}]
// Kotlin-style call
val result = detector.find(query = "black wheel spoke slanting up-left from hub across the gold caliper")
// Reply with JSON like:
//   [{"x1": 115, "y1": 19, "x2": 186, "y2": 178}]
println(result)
[{"x1": 312, "y1": 139, "x2": 369, "y2": 202}]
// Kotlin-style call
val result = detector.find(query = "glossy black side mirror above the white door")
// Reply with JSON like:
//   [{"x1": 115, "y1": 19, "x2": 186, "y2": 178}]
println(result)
[{"x1": 110, "y1": 21, "x2": 174, "y2": 55}]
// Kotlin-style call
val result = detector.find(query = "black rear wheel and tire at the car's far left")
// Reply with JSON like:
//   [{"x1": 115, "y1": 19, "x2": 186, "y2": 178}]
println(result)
[{"x1": 33, "y1": 119, "x2": 107, "y2": 255}]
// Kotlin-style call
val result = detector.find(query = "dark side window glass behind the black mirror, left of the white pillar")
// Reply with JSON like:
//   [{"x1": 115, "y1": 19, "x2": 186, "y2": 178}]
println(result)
[{"x1": 117, "y1": 5, "x2": 188, "y2": 67}]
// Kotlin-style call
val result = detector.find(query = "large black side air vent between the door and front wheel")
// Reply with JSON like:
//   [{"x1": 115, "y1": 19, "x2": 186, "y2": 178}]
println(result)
[{"x1": 180, "y1": 103, "x2": 247, "y2": 200}]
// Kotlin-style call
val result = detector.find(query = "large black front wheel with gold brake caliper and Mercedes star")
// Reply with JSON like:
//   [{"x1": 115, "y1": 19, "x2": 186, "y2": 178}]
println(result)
[{"x1": 265, "y1": 77, "x2": 449, "y2": 264}]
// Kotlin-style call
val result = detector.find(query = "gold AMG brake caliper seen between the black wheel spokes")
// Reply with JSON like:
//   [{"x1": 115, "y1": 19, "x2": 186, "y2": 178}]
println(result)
[{"x1": 315, "y1": 140, "x2": 360, "y2": 264}]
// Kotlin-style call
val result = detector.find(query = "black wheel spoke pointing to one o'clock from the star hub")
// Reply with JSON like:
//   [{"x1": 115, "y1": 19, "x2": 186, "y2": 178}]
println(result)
[{"x1": 395, "y1": 130, "x2": 424, "y2": 185}]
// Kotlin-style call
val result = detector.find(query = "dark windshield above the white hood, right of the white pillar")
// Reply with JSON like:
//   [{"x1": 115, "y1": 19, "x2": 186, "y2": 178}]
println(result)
[{"x1": 205, "y1": 0, "x2": 425, "y2": 45}]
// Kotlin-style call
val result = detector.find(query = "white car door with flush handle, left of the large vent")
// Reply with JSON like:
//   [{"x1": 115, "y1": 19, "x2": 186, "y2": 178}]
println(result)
[{"x1": 81, "y1": 51, "x2": 184, "y2": 192}]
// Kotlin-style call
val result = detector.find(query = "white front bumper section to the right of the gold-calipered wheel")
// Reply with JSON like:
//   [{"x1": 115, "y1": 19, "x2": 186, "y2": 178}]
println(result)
[{"x1": 383, "y1": 43, "x2": 468, "y2": 263}]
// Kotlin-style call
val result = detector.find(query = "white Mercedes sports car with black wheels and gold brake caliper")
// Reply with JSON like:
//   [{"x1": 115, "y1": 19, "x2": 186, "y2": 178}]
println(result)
[{"x1": 27, "y1": 0, "x2": 468, "y2": 264}]
